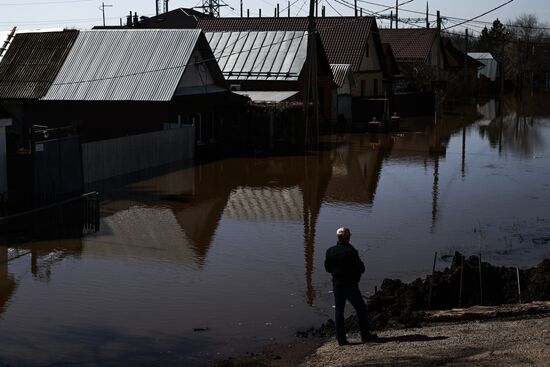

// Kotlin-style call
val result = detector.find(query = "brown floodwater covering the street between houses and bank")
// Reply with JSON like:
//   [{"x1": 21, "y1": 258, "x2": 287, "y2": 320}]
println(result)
[{"x1": 0, "y1": 99, "x2": 550, "y2": 366}]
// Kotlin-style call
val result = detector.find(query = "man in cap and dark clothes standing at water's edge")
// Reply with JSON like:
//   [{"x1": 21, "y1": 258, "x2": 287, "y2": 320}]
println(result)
[{"x1": 325, "y1": 227, "x2": 376, "y2": 345}]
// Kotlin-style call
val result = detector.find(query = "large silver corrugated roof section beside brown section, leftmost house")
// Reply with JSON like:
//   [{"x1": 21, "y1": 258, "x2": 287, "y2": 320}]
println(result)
[{"x1": 44, "y1": 29, "x2": 209, "y2": 101}]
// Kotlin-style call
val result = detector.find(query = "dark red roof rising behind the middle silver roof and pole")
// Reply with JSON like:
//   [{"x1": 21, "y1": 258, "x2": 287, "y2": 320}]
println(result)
[{"x1": 197, "y1": 17, "x2": 378, "y2": 71}]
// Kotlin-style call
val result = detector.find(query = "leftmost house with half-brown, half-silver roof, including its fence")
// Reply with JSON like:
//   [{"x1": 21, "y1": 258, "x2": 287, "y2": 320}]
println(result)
[{"x1": 0, "y1": 29, "x2": 248, "y2": 204}]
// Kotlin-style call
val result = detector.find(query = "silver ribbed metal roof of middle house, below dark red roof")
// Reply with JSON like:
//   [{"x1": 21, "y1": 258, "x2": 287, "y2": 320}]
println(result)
[{"x1": 206, "y1": 31, "x2": 307, "y2": 81}]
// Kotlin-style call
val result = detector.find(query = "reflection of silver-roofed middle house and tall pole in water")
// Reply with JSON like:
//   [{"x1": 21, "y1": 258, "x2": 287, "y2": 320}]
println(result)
[{"x1": 219, "y1": 155, "x2": 332, "y2": 304}]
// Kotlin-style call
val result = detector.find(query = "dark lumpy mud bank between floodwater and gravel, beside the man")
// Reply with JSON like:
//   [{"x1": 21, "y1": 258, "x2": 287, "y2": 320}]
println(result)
[{"x1": 304, "y1": 252, "x2": 550, "y2": 337}]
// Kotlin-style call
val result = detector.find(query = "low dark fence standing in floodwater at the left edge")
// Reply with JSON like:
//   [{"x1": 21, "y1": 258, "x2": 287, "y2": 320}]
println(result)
[{"x1": 0, "y1": 192, "x2": 99, "y2": 240}]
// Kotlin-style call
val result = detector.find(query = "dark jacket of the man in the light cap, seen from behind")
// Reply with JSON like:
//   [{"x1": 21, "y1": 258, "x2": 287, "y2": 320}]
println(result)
[{"x1": 325, "y1": 241, "x2": 365, "y2": 285}]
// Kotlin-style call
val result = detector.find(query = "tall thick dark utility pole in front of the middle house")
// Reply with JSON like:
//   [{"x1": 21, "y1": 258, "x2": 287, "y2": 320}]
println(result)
[{"x1": 304, "y1": 0, "x2": 319, "y2": 149}]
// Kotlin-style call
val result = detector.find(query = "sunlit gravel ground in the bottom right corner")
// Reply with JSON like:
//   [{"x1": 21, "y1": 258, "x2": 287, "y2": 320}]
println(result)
[{"x1": 301, "y1": 316, "x2": 550, "y2": 367}]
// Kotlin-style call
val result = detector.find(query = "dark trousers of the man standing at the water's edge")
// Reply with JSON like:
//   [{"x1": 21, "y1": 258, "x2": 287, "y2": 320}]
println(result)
[{"x1": 333, "y1": 283, "x2": 370, "y2": 342}]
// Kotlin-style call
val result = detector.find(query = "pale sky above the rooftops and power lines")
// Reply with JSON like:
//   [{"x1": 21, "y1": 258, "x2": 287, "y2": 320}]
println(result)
[{"x1": 0, "y1": 0, "x2": 550, "y2": 33}]
